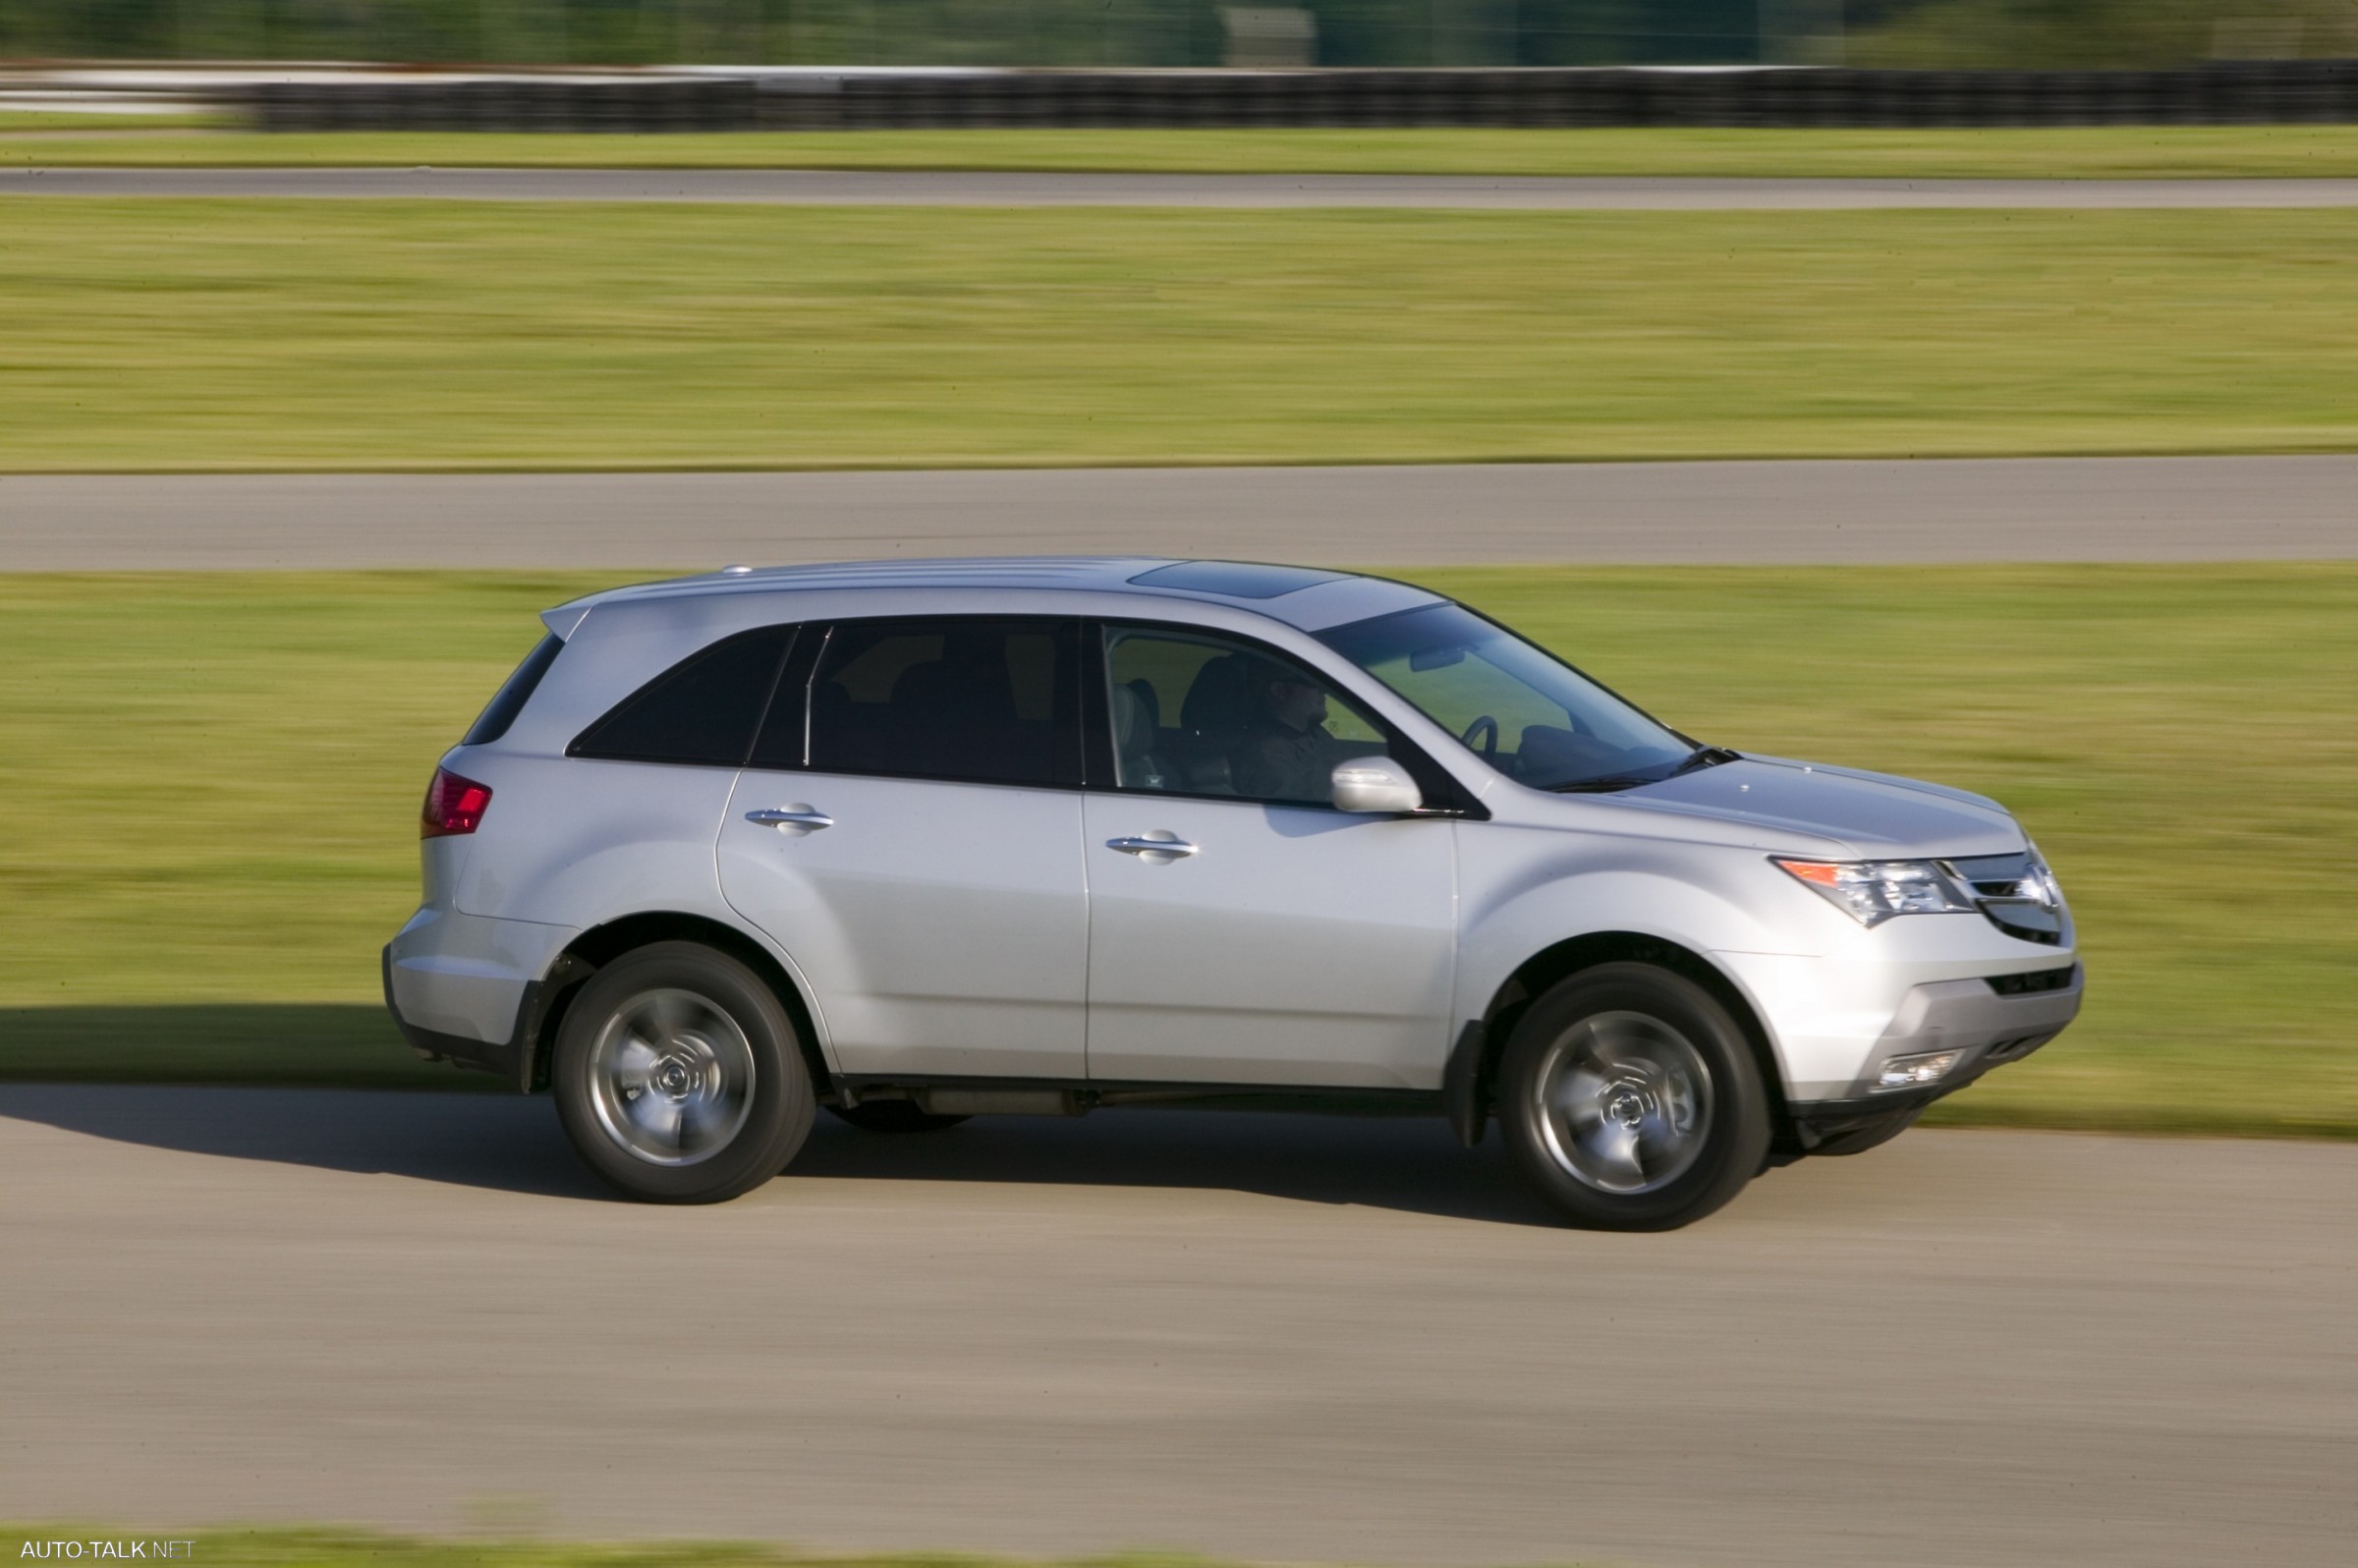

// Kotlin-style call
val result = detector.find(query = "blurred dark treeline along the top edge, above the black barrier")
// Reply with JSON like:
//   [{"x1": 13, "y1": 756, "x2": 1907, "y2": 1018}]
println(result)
[{"x1": 0, "y1": 0, "x2": 2358, "y2": 69}]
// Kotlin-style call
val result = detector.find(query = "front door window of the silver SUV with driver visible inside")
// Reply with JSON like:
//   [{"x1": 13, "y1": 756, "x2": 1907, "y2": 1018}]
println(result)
[{"x1": 1106, "y1": 627, "x2": 1391, "y2": 807}]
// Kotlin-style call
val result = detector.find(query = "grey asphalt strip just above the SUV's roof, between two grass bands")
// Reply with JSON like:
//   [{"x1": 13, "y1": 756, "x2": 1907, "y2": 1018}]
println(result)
[{"x1": 0, "y1": 458, "x2": 2358, "y2": 571}]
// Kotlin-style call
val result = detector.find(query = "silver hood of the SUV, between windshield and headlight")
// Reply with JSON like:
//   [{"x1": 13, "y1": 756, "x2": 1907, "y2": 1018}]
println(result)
[{"x1": 1601, "y1": 756, "x2": 2026, "y2": 861}]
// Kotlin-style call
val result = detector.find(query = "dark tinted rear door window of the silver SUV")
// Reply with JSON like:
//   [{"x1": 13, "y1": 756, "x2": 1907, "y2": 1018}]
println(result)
[{"x1": 809, "y1": 618, "x2": 1080, "y2": 788}]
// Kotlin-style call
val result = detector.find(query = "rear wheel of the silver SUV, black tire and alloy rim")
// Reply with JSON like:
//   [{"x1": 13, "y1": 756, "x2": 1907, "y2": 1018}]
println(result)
[{"x1": 552, "y1": 941, "x2": 815, "y2": 1203}]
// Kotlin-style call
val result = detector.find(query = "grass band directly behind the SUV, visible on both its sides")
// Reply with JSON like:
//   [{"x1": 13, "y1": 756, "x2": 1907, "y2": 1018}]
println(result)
[{"x1": 0, "y1": 564, "x2": 2358, "y2": 1137}]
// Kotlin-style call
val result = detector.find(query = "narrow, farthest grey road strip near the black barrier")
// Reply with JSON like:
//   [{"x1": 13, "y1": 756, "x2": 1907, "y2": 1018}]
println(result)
[{"x1": 14, "y1": 167, "x2": 2358, "y2": 212}]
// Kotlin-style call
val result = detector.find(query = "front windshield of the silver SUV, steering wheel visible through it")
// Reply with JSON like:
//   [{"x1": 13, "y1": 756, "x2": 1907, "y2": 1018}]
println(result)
[{"x1": 1320, "y1": 603, "x2": 1705, "y2": 790}]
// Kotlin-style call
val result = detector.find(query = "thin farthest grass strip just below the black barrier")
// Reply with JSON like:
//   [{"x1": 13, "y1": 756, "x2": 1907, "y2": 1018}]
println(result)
[{"x1": 14, "y1": 123, "x2": 2358, "y2": 179}]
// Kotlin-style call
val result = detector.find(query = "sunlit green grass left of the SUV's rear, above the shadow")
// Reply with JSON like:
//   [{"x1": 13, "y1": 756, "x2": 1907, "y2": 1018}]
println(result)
[{"x1": 0, "y1": 573, "x2": 590, "y2": 1009}]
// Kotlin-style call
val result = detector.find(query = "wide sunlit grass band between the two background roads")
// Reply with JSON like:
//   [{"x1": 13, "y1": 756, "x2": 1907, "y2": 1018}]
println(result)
[{"x1": 0, "y1": 198, "x2": 2358, "y2": 472}]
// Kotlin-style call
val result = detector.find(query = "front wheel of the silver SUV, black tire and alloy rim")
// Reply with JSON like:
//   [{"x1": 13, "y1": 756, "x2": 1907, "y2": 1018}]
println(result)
[{"x1": 1497, "y1": 965, "x2": 1768, "y2": 1231}]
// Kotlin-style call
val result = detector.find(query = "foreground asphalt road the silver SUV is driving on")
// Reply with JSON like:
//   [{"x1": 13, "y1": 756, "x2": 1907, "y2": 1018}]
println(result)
[{"x1": 0, "y1": 1085, "x2": 2358, "y2": 1568}]
